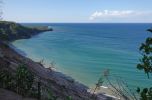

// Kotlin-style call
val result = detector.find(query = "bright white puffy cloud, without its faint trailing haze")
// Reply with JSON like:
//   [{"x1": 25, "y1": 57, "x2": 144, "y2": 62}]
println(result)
[{"x1": 89, "y1": 10, "x2": 143, "y2": 20}]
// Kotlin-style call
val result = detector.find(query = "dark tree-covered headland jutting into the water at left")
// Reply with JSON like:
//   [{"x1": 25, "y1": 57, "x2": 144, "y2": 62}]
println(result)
[{"x1": 0, "y1": 21, "x2": 52, "y2": 41}]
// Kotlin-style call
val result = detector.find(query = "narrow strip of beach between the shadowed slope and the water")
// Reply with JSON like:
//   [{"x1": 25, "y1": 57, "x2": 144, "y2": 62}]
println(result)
[{"x1": 9, "y1": 42, "x2": 118, "y2": 99}]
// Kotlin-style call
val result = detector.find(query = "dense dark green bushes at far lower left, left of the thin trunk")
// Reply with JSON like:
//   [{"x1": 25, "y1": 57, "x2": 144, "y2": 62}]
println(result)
[{"x1": 0, "y1": 65, "x2": 34, "y2": 96}]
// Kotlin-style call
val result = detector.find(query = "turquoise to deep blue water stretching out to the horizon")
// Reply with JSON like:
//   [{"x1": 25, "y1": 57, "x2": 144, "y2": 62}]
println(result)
[{"x1": 13, "y1": 24, "x2": 152, "y2": 87}]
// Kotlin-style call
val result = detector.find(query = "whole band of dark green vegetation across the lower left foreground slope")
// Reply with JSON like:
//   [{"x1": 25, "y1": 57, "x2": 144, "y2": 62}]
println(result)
[{"x1": 0, "y1": 64, "x2": 72, "y2": 100}]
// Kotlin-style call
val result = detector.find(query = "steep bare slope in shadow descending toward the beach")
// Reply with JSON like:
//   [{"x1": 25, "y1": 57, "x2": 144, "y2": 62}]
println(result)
[{"x1": 0, "y1": 43, "x2": 92, "y2": 100}]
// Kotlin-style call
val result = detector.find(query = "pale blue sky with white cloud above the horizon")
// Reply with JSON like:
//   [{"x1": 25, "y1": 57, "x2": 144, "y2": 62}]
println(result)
[{"x1": 2, "y1": 0, "x2": 152, "y2": 23}]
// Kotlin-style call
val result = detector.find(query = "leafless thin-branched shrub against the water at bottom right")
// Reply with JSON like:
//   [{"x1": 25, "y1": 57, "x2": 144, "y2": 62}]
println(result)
[{"x1": 93, "y1": 69, "x2": 138, "y2": 100}]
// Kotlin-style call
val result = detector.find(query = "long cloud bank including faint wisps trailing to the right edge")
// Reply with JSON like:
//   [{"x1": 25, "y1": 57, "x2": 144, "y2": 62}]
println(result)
[{"x1": 89, "y1": 10, "x2": 152, "y2": 21}]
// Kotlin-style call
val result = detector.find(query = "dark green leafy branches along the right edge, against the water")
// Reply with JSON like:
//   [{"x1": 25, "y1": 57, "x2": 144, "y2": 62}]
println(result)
[{"x1": 137, "y1": 29, "x2": 152, "y2": 100}]
